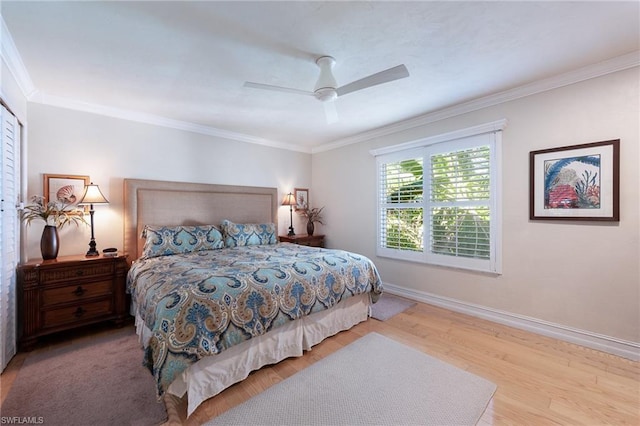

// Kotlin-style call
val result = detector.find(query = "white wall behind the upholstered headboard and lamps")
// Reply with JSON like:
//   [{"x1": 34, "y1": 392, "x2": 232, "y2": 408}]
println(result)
[{"x1": 26, "y1": 103, "x2": 311, "y2": 258}]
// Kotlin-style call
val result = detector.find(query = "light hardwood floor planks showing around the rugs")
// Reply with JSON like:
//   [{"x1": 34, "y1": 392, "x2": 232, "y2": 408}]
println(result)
[{"x1": 1, "y1": 303, "x2": 640, "y2": 426}]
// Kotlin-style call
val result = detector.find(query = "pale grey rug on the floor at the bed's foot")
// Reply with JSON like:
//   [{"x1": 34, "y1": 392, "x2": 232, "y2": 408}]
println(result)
[{"x1": 206, "y1": 333, "x2": 496, "y2": 426}]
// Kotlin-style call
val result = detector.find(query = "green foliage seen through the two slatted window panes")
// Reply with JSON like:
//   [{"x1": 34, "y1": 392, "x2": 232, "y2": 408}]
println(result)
[{"x1": 384, "y1": 147, "x2": 490, "y2": 259}]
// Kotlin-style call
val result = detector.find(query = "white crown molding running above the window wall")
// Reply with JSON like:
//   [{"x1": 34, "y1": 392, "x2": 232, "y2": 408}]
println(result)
[{"x1": 311, "y1": 50, "x2": 640, "y2": 153}]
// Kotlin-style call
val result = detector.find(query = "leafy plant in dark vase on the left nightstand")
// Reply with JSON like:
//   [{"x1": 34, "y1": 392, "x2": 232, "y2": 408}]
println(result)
[{"x1": 22, "y1": 195, "x2": 88, "y2": 260}]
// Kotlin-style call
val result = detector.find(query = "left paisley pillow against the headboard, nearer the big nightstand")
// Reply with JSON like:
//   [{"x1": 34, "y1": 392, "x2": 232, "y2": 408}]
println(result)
[{"x1": 142, "y1": 225, "x2": 224, "y2": 257}]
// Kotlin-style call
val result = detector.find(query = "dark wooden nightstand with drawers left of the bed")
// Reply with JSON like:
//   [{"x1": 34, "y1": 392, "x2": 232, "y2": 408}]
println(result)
[{"x1": 18, "y1": 254, "x2": 129, "y2": 350}]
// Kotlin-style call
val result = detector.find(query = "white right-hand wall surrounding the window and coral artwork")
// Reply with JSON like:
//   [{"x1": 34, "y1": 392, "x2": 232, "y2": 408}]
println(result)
[{"x1": 312, "y1": 67, "x2": 640, "y2": 342}]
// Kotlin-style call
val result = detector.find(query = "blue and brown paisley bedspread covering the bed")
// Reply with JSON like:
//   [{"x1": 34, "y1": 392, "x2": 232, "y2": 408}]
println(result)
[{"x1": 127, "y1": 243, "x2": 382, "y2": 396}]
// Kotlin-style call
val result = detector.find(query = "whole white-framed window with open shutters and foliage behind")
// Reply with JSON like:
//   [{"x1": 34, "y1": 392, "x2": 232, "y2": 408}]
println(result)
[{"x1": 373, "y1": 122, "x2": 504, "y2": 273}]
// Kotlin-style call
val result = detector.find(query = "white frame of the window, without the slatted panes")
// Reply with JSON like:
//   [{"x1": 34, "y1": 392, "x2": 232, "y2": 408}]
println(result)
[{"x1": 371, "y1": 120, "x2": 506, "y2": 274}]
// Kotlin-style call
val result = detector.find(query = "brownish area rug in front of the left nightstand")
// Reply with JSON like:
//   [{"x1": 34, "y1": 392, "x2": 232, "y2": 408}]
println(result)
[{"x1": 0, "y1": 327, "x2": 167, "y2": 426}]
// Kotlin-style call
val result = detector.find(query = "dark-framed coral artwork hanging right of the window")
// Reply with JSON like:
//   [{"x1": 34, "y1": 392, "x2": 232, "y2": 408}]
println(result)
[{"x1": 529, "y1": 139, "x2": 620, "y2": 221}]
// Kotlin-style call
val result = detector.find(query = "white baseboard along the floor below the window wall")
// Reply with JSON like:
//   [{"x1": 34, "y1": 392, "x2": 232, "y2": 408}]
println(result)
[{"x1": 384, "y1": 283, "x2": 640, "y2": 361}]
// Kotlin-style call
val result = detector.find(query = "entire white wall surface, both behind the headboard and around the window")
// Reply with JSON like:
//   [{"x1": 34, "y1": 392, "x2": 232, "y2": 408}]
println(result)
[{"x1": 8, "y1": 68, "x2": 640, "y2": 354}]
